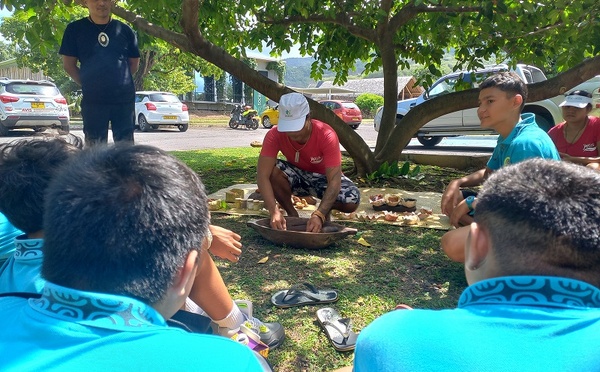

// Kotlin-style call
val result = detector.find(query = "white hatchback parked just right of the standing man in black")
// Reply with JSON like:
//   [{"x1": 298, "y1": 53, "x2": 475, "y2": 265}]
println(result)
[{"x1": 135, "y1": 91, "x2": 190, "y2": 132}]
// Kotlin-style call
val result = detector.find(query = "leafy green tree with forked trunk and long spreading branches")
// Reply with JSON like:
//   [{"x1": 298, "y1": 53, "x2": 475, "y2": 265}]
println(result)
[{"x1": 2, "y1": 0, "x2": 600, "y2": 174}]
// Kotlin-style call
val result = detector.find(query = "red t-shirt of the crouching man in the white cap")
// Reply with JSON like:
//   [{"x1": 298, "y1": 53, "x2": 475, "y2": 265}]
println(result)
[{"x1": 260, "y1": 119, "x2": 342, "y2": 174}]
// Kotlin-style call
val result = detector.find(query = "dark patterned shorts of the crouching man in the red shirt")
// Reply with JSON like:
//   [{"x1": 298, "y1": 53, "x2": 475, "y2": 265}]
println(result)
[{"x1": 275, "y1": 159, "x2": 360, "y2": 204}]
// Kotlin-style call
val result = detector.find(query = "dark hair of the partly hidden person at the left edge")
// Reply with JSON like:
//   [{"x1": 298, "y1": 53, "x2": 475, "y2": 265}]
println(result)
[{"x1": 0, "y1": 135, "x2": 83, "y2": 234}]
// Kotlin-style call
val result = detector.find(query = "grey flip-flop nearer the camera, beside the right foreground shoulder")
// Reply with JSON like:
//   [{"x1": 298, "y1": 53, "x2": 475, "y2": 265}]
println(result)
[{"x1": 317, "y1": 307, "x2": 358, "y2": 351}]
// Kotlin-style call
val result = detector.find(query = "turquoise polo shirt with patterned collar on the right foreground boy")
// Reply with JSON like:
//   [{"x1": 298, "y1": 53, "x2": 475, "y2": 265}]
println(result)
[{"x1": 354, "y1": 276, "x2": 600, "y2": 372}]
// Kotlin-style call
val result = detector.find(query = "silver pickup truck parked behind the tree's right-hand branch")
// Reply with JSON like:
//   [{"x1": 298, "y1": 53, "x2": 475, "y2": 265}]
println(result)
[{"x1": 374, "y1": 64, "x2": 592, "y2": 146}]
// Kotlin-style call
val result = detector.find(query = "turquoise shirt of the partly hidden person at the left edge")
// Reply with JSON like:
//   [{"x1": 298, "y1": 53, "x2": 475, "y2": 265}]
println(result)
[{"x1": 0, "y1": 235, "x2": 46, "y2": 293}]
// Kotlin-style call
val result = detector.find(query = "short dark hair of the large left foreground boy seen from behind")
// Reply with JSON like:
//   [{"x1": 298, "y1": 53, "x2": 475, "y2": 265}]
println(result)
[{"x1": 42, "y1": 144, "x2": 210, "y2": 304}]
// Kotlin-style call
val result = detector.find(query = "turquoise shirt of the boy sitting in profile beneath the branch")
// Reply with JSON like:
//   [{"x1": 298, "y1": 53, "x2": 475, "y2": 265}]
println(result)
[{"x1": 487, "y1": 113, "x2": 560, "y2": 170}]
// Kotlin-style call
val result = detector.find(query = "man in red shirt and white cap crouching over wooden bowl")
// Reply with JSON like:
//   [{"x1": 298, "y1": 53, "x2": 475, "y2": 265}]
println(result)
[{"x1": 257, "y1": 93, "x2": 360, "y2": 232}]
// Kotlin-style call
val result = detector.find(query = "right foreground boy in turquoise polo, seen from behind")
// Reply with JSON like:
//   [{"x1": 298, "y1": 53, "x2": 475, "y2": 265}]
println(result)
[{"x1": 354, "y1": 159, "x2": 600, "y2": 371}]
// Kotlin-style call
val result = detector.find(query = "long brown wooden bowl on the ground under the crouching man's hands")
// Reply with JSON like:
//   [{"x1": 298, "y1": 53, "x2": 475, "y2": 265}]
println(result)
[{"x1": 247, "y1": 217, "x2": 357, "y2": 249}]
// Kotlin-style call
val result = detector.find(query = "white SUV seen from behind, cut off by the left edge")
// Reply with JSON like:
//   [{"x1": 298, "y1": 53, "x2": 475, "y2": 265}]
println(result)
[{"x1": 0, "y1": 78, "x2": 69, "y2": 136}]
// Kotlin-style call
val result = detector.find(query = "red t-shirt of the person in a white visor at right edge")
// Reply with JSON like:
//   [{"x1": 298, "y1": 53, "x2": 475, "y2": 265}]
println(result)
[{"x1": 548, "y1": 116, "x2": 600, "y2": 158}]
